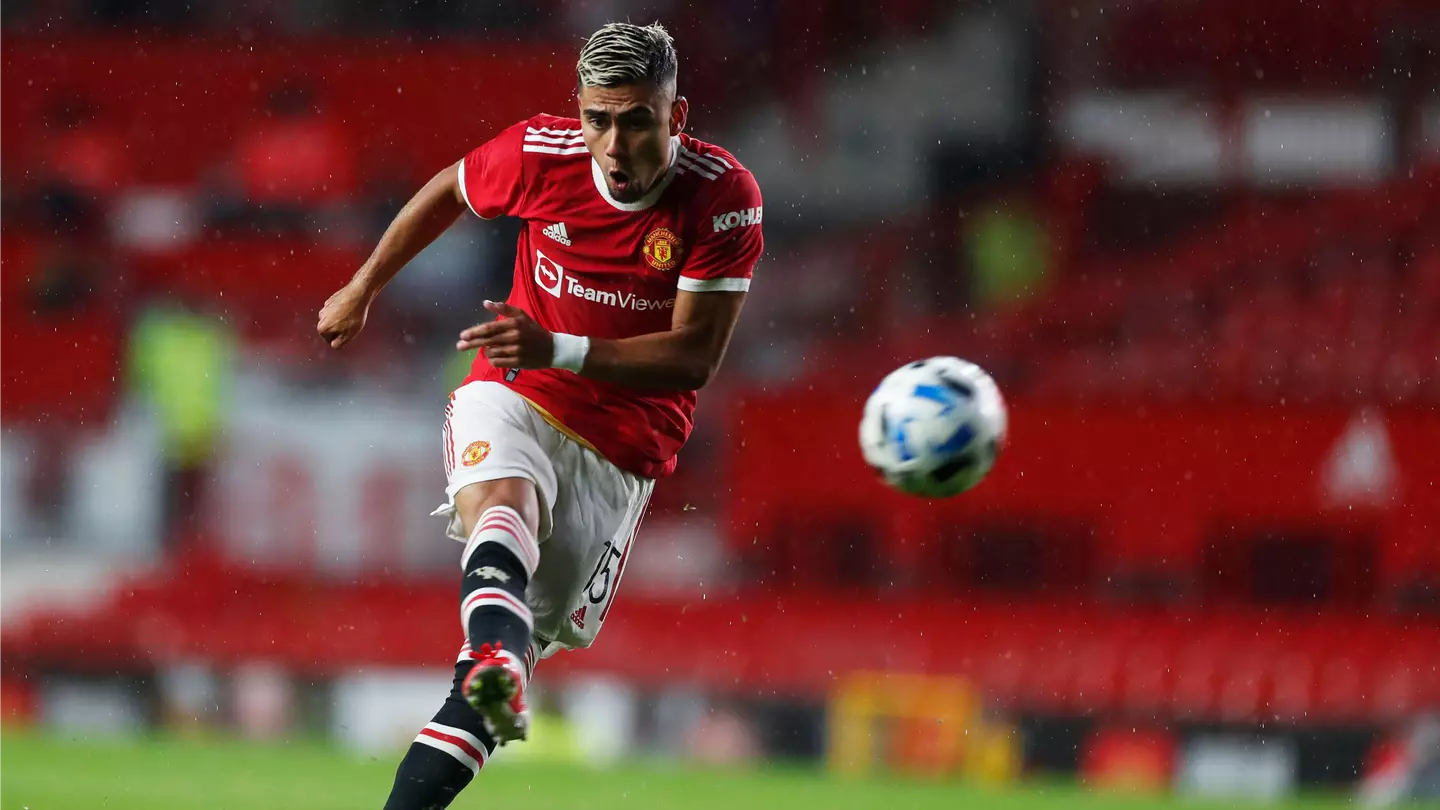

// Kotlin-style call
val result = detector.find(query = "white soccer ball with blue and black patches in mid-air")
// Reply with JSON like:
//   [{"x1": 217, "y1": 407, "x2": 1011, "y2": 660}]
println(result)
[{"x1": 860, "y1": 357, "x2": 1007, "y2": 497}]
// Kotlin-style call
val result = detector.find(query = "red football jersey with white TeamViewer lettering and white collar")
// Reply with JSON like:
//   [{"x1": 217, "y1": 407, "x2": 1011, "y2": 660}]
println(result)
[{"x1": 459, "y1": 115, "x2": 763, "y2": 479}]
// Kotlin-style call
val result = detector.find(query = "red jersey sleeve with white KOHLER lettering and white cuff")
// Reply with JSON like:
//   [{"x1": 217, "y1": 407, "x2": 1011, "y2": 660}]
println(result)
[{"x1": 678, "y1": 172, "x2": 765, "y2": 293}]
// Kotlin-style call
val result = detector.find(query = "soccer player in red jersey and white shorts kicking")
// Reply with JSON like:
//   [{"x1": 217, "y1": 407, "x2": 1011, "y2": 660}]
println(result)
[{"x1": 317, "y1": 23, "x2": 763, "y2": 810}]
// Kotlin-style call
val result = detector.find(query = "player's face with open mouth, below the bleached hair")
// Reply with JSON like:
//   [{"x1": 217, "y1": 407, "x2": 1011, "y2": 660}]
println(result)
[{"x1": 580, "y1": 84, "x2": 688, "y2": 202}]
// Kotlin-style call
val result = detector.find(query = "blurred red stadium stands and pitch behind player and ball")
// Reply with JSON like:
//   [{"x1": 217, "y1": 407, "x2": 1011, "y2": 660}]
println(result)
[{"x1": 0, "y1": 0, "x2": 1440, "y2": 809}]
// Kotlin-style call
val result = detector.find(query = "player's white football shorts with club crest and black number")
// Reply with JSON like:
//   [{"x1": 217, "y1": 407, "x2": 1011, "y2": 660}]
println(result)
[{"x1": 433, "y1": 382, "x2": 655, "y2": 657}]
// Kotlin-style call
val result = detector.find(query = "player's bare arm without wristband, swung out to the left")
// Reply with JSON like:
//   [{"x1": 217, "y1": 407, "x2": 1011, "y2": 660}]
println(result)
[{"x1": 315, "y1": 163, "x2": 465, "y2": 349}]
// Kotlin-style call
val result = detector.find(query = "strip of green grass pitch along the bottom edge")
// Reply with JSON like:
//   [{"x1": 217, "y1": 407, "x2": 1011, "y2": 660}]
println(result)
[{"x1": 0, "y1": 732, "x2": 1370, "y2": 810}]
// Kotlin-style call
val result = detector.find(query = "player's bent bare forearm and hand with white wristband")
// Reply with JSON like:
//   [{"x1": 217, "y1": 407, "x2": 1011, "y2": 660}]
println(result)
[{"x1": 455, "y1": 290, "x2": 744, "y2": 391}]
